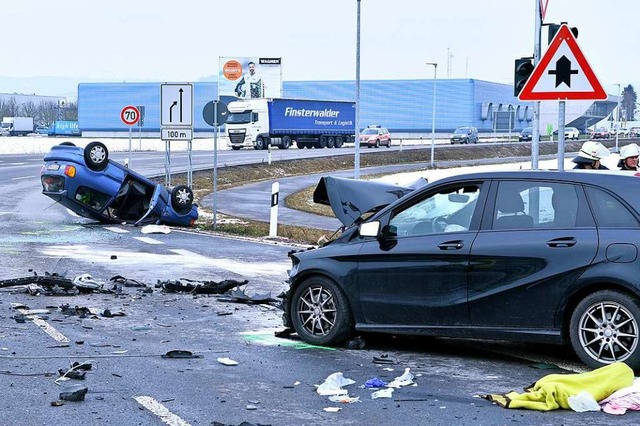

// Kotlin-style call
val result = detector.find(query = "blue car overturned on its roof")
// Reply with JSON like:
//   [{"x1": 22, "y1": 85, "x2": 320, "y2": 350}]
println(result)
[{"x1": 40, "y1": 142, "x2": 198, "y2": 226}]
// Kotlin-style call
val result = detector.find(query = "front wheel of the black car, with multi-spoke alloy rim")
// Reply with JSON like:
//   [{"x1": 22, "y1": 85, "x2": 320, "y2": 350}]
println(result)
[{"x1": 291, "y1": 276, "x2": 352, "y2": 345}]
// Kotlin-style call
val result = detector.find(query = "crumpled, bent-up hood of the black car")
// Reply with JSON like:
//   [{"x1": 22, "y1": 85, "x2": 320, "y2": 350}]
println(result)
[{"x1": 313, "y1": 176, "x2": 427, "y2": 227}]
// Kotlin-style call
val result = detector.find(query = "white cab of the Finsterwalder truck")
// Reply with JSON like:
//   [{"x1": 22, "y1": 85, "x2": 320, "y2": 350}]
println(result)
[{"x1": 225, "y1": 99, "x2": 271, "y2": 150}]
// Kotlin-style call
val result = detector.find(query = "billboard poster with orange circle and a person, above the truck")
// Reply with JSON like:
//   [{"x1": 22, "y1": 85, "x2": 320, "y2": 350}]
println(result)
[{"x1": 218, "y1": 56, "x2": 282, "y2": 99}]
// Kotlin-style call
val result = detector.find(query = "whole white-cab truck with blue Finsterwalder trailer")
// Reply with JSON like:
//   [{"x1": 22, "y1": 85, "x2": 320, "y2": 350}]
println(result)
[{"x1": 225, "y1": 98, "x2": 356, "y2": 150}]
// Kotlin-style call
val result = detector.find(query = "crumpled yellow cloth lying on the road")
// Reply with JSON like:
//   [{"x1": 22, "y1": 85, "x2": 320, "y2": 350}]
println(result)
[{"x1": 484, "y1": 362, "x2": 634, "y2": 411}]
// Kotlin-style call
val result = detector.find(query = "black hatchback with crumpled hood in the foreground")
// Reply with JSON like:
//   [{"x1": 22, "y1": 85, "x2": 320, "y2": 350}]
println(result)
[{"x1": 283, "y1": 170, "x2": 640, "y2": 369}]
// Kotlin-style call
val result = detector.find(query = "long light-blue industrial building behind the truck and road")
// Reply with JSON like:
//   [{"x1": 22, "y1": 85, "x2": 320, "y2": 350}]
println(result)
[{"x1": 78, "y1": 79, "x2": 615, "y2": 137}]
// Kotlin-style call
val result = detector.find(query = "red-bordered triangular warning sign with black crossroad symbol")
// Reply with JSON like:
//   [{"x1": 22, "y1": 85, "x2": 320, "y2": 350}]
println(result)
[{"x1": 518, "y1": 24, "x2": 607, "y2": 101}]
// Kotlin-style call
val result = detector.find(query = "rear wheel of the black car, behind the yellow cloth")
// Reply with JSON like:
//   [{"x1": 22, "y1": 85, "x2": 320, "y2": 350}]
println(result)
[{"x1": 570, "y1": 290, "x2": 640, "y2": 369}]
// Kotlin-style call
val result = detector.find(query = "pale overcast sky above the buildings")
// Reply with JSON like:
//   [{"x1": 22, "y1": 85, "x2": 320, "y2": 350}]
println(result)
[{"x1": 5, "y1": 0, "x2": 640, "y2": 95}]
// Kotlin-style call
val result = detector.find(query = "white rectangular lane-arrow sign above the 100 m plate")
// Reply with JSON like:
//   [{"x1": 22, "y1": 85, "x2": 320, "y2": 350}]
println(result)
[{"x1": 160, "y1": 83, "x2": 193, "y2": 126}]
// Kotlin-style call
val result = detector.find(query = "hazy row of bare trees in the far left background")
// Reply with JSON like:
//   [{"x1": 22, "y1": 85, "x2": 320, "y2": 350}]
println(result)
[{"x1": 0, "y1": 97, "x2": 78, "y2": 126}]
